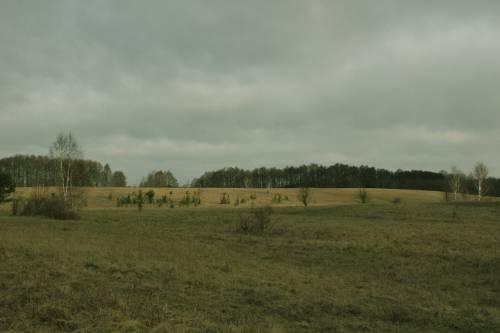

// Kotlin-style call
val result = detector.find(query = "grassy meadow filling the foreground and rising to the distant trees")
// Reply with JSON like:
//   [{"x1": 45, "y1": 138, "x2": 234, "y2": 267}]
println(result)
[{"x1": 0, "y1": 189, "x2": 500, "y2": 333}]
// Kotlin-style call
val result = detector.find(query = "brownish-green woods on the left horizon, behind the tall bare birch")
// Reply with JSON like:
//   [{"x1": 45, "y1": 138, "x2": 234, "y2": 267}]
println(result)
[{"x1": 0, "y1": 155, "x2": 127, "y2": 187}]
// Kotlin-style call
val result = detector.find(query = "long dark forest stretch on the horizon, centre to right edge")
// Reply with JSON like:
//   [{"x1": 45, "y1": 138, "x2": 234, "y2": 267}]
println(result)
[{"x1": 191, "y1": 164, "x2": 500, "y2": 196}]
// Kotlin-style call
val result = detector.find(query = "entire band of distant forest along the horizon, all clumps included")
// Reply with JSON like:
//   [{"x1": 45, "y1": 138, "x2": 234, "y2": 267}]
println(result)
[{"x1": 0, "y1": 155, "x2": 500, "y2": 196}]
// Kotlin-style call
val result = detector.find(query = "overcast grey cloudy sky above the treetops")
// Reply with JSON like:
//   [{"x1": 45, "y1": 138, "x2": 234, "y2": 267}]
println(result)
[{"x1": 0, "y1": 0, "x2": 500, "y2": 184}]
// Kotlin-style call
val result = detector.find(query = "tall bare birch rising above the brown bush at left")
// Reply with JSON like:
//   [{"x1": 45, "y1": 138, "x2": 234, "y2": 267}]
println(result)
[{"x1": 50, "y1": 133, "x2": 83, "y2": 201}]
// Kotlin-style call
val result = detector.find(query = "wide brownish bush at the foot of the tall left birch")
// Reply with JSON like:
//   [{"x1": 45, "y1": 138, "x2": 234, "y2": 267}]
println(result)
[{"x1": 12, "y1": 193, "x2": 79, "y2": 220}]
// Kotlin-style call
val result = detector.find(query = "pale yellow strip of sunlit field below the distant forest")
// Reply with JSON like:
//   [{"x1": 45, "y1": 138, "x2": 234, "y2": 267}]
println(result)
[{"x1": 4, "y1": 187, "x2": 498, "y2": 209}]
